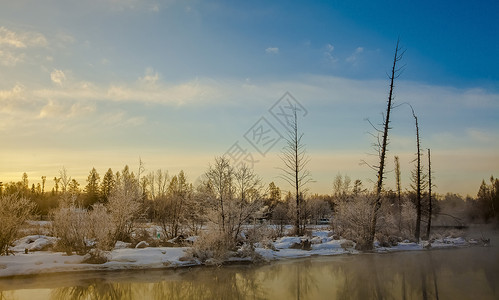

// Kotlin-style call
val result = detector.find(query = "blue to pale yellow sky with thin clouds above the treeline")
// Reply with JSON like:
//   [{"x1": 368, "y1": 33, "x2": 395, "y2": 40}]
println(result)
[{"x1": 0, "y1": 0, "x2": 499, "y2": 196}]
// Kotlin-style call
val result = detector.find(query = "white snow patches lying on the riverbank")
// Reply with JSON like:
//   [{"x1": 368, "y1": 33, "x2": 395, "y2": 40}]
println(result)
[{"x1": 0, "y1": 229, "x2": 477, "y2": 277}]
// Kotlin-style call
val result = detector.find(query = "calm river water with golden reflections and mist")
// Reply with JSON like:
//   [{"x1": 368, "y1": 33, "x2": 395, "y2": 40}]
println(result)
[{"x1": 0, "y1": 247, "x2": 499, "y2": 299}]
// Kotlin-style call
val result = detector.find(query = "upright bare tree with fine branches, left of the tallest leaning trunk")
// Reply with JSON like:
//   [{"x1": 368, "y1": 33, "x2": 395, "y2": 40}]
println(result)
[{"x1": 279, "y1": 107, "x2": 312, "y2": 235}]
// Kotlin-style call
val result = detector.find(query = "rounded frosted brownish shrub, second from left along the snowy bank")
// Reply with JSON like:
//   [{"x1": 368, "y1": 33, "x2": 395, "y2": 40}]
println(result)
[{"x1": 52, "y1": 205, "x2": 91, "y2": 255}]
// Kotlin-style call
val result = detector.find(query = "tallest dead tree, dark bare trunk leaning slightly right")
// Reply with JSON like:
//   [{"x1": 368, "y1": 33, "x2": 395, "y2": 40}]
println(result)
[{"x1": 368, "y1": 40, "x2": 405, "y2": 250}]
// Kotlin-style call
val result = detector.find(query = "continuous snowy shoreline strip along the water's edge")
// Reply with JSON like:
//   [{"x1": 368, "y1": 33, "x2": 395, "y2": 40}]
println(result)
[{"x1": 0, "y1": 231, "x2": 481, "y2": 284}]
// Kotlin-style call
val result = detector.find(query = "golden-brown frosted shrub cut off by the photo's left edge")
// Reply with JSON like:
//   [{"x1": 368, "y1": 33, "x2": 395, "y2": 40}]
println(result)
[{"x1": 0, "y1": 195, "x2": 35, "y2": 255}]
